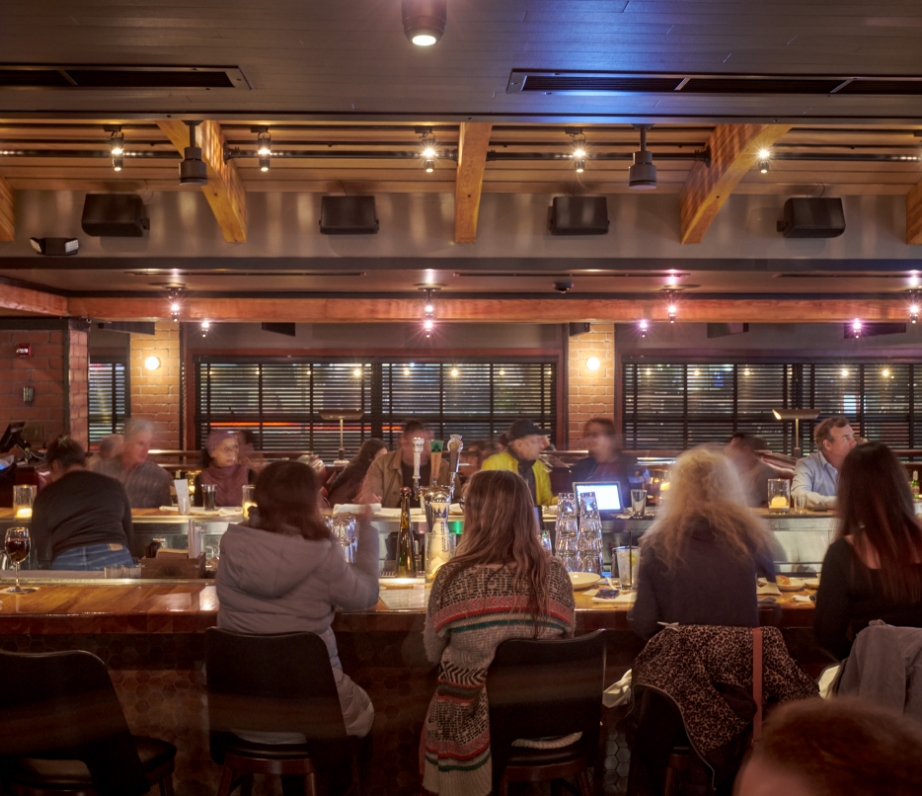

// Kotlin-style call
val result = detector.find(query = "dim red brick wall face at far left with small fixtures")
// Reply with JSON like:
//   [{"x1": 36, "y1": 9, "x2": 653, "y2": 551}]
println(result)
[{"x1": 0, "y1": 330, "x2": 65, "y2": 443}]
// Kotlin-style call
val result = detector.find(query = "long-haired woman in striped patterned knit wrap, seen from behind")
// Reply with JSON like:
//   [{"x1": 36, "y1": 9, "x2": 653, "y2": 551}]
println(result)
[{"x1": 420, "y1": 470, "x2": 574, "y2": 796}]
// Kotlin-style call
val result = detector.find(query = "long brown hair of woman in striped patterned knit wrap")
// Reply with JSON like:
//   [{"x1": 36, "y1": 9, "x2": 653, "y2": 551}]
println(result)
[{"x1": 443, "y1": 470, "x2": 549, "y2": 638}]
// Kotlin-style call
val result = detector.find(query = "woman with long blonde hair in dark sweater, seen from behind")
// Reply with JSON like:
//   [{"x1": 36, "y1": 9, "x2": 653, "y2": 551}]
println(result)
[{"x1": 628, "y1": 448, "x2": 775, "y2": 639}]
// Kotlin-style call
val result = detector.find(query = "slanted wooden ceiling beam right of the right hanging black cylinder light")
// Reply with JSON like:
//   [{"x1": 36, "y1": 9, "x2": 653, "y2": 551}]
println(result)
[{"x1": 679, "y1": 124, "x2": 791, "y2": 243}]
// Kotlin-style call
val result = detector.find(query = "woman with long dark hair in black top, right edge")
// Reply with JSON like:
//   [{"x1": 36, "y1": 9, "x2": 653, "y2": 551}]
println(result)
[{"x1": 813, "y1": 442, "x2": 922, "y2": 659}]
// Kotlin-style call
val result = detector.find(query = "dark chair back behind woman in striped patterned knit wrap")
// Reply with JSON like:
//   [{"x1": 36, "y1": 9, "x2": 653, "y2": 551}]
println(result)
[{"x1": 486, "y1": 630, "x2": 606, "y2": 778}]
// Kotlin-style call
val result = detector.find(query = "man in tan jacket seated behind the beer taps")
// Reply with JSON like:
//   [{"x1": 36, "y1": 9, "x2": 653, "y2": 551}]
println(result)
[{"x1": 359, "y1": 420, "x2": 450, "y2": 509}]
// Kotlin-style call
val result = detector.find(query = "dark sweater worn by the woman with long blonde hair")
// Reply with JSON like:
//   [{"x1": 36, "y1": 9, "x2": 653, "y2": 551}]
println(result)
[{"x1": 628, "y1": 523, "x2": 775, "y2": 639}]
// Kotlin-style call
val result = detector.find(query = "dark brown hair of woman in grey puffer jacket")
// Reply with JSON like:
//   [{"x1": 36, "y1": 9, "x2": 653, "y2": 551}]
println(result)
[{"x1": 255, "y1": 462, "x2": 330, "y2": 539}]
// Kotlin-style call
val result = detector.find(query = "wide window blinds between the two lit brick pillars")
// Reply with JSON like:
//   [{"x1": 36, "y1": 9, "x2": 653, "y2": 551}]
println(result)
[{"x1": 195, "y1": 357, "x2": 557, "y2": 460}]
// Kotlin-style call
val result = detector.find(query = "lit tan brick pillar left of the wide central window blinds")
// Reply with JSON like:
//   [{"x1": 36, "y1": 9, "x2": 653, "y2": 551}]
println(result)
[{"x1": 131, "y1": 321, "x2": 182, "y2": 449}]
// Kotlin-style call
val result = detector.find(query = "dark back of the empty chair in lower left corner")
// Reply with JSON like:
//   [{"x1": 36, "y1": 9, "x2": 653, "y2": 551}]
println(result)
[{"x1": 0, "y1": 650, "x2": 150, "y2": 796}]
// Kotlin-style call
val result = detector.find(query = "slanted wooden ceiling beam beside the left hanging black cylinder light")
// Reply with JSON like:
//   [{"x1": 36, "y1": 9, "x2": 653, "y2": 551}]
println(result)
[{"x1": 157, "y1": 119, "x2": 247, "y2": 243}]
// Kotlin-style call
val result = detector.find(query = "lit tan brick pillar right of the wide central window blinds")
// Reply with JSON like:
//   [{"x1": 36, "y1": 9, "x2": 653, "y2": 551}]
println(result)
[{"x1": 567, "y1": 323, "x2": 615, "y2": 448}]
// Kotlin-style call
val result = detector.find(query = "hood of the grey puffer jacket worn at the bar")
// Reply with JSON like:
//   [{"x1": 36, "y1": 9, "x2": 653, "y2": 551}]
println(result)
[{"x1": 218, "y1": 525, "x2": 333, "y2": 599}]
